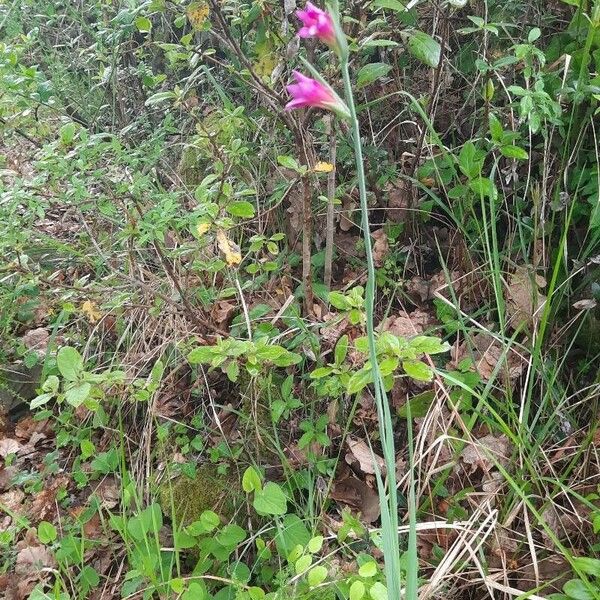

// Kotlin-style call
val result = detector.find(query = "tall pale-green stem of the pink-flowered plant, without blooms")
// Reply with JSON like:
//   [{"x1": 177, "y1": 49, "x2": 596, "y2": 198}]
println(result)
[{"x1": 332, "y1": 0, "x2": 412, "y2": 600}]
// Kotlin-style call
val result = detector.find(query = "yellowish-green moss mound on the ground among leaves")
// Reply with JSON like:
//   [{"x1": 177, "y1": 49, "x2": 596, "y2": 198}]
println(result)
[{"x1": 159, "y1": 463, "x2": 241, "y2": 526}]
